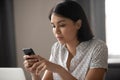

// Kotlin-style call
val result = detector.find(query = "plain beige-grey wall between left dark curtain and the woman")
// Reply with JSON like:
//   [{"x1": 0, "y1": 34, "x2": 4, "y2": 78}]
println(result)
[{"x1": 14, "y1": 0, "x2": 60, "y2": 80}]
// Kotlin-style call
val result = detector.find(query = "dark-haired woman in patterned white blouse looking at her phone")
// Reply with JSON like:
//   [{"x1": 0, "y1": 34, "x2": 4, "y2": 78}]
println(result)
[{"x1": 24, "y1": 1, "x2": 108, "y2": 80}]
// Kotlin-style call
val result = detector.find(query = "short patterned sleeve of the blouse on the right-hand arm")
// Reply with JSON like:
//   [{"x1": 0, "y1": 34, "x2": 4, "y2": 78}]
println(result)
[{"x1": 90, "y1": 42, "x2": 108, "y2": 69}]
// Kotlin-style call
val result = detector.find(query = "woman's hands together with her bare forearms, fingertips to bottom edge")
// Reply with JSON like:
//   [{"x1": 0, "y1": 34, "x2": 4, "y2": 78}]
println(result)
[{"x1": 24, "y1": 55, "x2": 77, "y2": 80}]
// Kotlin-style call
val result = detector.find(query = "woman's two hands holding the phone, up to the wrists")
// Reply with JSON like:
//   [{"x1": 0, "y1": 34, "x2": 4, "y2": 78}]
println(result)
[{"x1": 24, "y1": 55, "x2": 59, "y2": 75}]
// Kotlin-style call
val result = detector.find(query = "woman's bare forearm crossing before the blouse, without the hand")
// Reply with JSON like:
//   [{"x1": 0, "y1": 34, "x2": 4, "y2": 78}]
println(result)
[{"x1": 57, "y1": 66, "x2": 77, "y2": 80}]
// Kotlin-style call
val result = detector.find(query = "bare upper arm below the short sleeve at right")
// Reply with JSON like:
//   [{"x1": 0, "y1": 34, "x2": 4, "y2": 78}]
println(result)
[{"x1": 85, "y1": 68, "x2": 106, "y2": 80}]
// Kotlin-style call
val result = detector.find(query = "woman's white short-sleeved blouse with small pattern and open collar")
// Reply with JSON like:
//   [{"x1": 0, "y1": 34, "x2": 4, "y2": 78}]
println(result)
[{"x1": 50, "y1": 39, "x2": 108, "y2": 80}]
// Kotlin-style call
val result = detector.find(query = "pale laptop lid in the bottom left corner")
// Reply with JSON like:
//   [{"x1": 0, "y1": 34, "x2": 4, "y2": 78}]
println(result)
[{"x1": 0, "y1": 68, "x2": 26, "y2": 80}]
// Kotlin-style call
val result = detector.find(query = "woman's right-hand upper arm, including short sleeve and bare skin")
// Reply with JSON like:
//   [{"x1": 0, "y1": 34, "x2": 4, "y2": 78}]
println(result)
[{"x1": 85, "y1": 42, "x2": 108, "y2": 80}]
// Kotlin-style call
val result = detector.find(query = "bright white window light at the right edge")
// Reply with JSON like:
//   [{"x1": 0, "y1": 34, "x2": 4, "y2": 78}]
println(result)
[{"x1": 105, "y1": 0, "x2": 120, "y2": 56}]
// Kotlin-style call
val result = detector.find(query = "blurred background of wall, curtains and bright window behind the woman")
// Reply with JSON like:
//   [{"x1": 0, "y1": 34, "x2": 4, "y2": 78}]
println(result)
[{"x1": 0, "y1": 0, "x2": 120, "y2": 80}]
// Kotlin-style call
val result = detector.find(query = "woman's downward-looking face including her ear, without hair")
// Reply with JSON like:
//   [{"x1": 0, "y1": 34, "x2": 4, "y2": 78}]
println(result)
[{"x1": 51, "y1": 14, "x2": 81, "y2": 44}]
